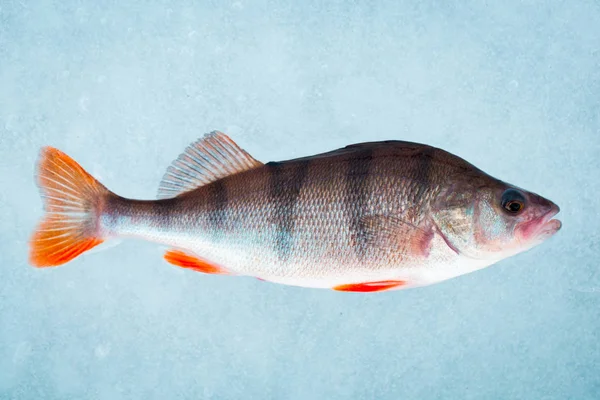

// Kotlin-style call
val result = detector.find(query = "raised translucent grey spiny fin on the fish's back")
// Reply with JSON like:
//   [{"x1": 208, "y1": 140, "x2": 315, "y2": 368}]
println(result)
[{"x1": 158, "y1": 131, "x2": 263, "y2": 199}]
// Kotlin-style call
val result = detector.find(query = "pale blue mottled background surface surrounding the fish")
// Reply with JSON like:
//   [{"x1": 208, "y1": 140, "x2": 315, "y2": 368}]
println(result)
[{"x1": 0, "y1": 0, "x2": 600, "y2": 400}]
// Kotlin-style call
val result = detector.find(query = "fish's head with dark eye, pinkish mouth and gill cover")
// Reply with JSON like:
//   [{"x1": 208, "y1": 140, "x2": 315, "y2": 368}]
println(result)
[{"x1": 433, "y1": 176, "x2": 561, "y2": 262}]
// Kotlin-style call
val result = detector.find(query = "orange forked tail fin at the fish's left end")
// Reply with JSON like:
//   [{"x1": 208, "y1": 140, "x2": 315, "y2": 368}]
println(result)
[{"x1": 29, "y1": 147, "x2": 111, "y2": 267}]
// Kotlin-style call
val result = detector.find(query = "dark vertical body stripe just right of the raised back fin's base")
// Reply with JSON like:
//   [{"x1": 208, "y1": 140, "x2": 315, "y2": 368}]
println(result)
[{"x1": 267, "y1": 161, "x2": 309, "y2": 262}]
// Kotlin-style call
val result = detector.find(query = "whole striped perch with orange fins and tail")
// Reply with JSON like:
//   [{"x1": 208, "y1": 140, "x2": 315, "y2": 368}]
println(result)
[{"x1": 29, "y1": 131, "x2": 562, "y2": 293}]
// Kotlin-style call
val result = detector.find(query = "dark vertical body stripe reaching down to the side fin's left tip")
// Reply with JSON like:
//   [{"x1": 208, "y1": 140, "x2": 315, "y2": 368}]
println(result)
[{"x1": 344, "y1": 148, "x2": 373, "y2": 258}]
